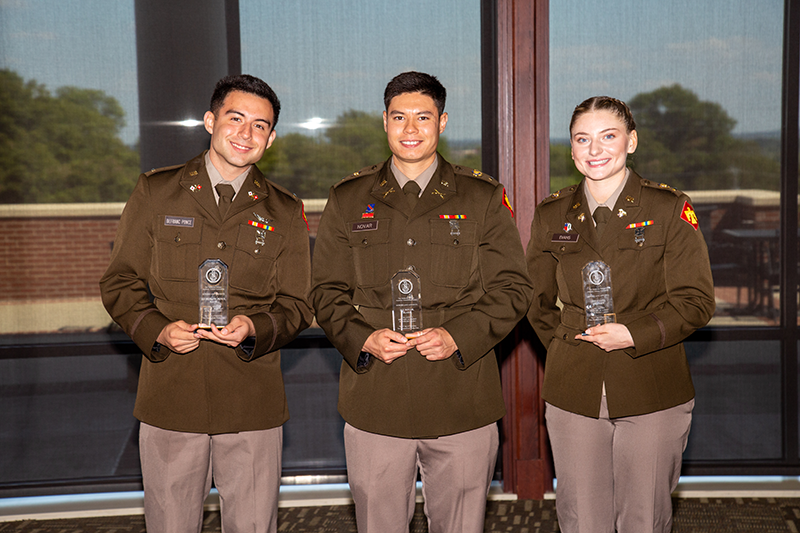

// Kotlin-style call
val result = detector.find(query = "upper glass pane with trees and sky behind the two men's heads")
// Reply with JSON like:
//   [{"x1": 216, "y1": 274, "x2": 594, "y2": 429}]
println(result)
[{"x1": 240, "y1": 0, "x2": 481, "y2": 202}]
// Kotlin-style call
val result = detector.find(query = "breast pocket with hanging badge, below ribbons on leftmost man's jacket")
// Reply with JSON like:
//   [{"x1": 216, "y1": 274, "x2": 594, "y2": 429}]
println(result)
[{"x1": 230, "y1": 224, "x2": 284, "y2": 295}]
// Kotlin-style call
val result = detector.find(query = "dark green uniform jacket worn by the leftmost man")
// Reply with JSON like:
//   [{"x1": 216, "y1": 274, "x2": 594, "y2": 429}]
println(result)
[{"x1": 100, "y1": 155, "x2": 313, "y2": 434}]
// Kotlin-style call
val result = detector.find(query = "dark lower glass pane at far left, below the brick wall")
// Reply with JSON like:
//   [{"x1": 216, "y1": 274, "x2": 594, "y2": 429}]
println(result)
[{"x1": 0, "y1": 353, "x2": 140, "y2": 484}]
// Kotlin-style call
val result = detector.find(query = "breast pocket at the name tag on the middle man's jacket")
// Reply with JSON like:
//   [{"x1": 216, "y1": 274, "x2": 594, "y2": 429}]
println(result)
[{"x1": 347, "y1": 219, "x2": 391, "y2": 287}]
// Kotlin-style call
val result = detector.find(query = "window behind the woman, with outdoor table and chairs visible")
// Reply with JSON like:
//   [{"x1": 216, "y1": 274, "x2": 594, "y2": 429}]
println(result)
[{"x1": 550, "y1": 0, "x2": 797, "y2": 473}]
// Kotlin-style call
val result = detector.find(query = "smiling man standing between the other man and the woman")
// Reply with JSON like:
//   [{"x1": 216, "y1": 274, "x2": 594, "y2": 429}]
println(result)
[{"x1": 312, "y1": 72, "x2": 531, "y2": 533}]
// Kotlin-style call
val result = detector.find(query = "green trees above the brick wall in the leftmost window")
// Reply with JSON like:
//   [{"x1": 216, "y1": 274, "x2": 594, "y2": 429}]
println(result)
[{"x1": 0, "y1": 69, "x2": 139, "y2": 204}]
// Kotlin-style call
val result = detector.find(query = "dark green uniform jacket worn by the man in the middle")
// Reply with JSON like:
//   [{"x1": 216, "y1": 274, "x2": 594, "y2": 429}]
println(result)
[{"x1": 312, "y1": 156, "x2": 531, "y2": 438}]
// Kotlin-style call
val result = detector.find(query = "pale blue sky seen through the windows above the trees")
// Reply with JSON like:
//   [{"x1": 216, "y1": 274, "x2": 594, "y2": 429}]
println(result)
[{"x1": 0, "y1": 0, "x2": 783, "y2": 144}]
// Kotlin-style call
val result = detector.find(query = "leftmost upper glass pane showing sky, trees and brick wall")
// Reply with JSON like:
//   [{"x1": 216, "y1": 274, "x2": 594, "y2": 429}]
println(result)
[{"x1": 0, "y1": 0, "x2": 139, "y2": 335}]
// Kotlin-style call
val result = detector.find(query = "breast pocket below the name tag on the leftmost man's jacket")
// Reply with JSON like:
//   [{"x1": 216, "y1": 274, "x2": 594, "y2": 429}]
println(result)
[{"x1": 155, "y1": 217, "x2": 203, "y2": 281}]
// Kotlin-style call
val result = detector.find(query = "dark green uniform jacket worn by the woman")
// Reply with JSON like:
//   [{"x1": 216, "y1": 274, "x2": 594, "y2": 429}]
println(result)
[{"x1": 527, "y1": 172, "x2": 714, "y2": 418}]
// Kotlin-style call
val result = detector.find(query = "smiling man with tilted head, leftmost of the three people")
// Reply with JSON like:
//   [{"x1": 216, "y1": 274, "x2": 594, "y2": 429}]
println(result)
[{"x1": 100, "y1": 75, "x2": 312, "y2": 533}]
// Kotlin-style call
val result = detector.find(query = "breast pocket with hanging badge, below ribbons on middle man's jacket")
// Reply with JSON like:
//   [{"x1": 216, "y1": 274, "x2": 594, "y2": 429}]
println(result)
[{"x1": 430, "y1": 219, "x2": 478, "y2": 287}]
